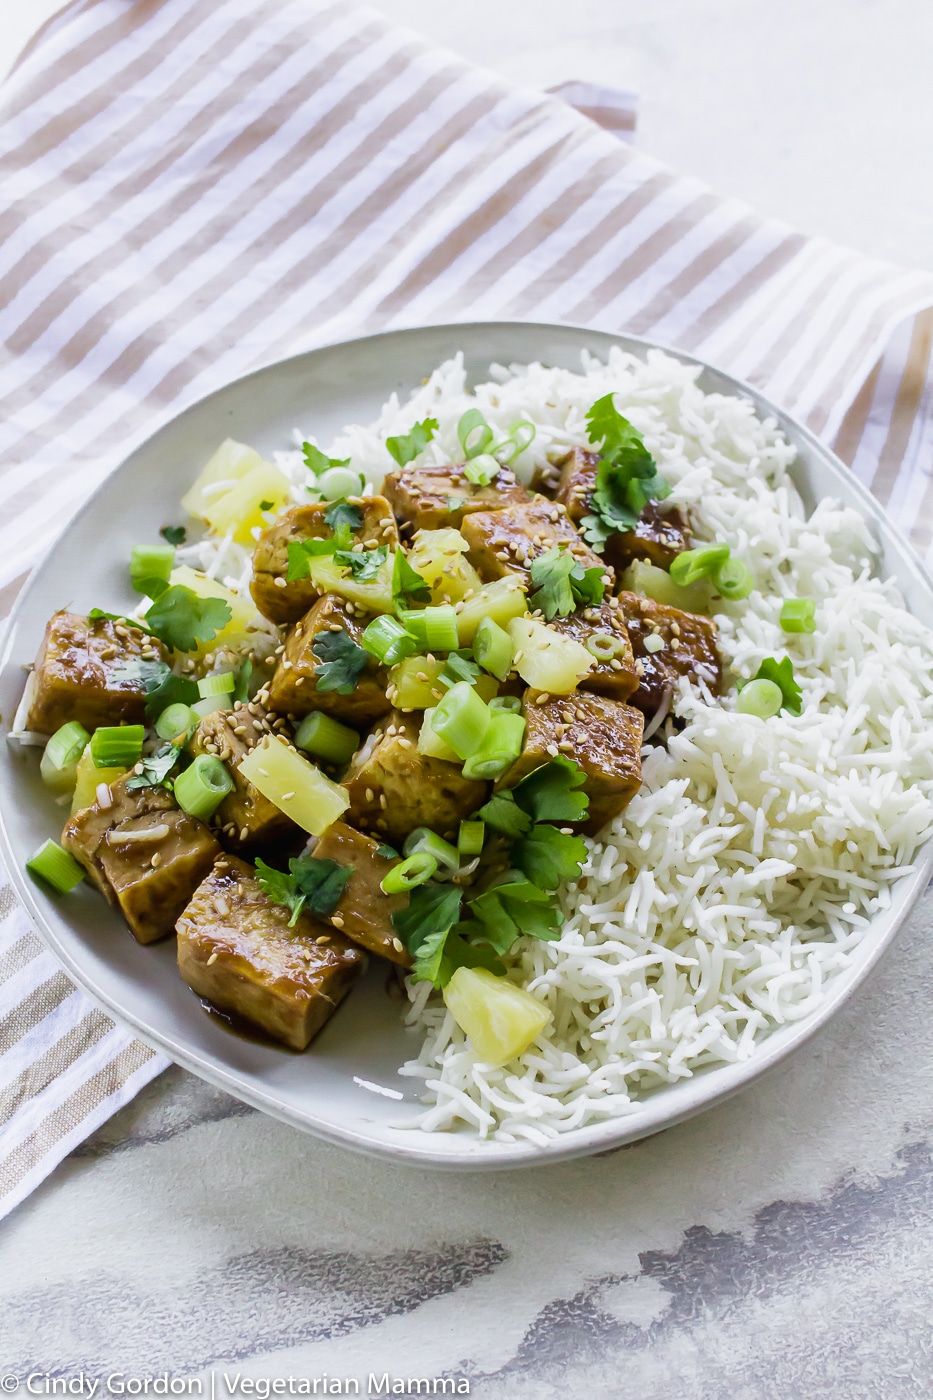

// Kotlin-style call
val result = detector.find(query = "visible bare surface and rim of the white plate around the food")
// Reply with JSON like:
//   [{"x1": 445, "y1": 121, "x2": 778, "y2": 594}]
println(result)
[{"x1": 0, "y1": 322, "x2": 933, "y2": 1170}]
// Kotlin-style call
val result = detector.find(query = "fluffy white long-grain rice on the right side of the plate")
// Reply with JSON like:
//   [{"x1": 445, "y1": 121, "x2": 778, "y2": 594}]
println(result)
[{"x1": 147, "y1": 350, "x2": 933, "y2": 1142}]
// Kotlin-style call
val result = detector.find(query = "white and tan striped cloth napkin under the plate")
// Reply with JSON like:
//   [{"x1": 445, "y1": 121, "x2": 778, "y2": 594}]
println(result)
[{"x1": 0, "y1": 0, "x2": 933, "y2": 1215}]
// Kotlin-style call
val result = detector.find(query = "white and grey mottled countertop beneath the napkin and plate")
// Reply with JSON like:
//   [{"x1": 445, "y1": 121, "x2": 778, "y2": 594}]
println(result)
[{"x1": 0, "y1": 0, "x2": 933, "y2": 1400}]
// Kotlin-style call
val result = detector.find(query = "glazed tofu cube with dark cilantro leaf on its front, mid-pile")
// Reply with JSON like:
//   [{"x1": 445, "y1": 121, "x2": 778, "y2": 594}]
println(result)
[{"x1": 268, "y1": 594, "x2": 392, "y2": 728}]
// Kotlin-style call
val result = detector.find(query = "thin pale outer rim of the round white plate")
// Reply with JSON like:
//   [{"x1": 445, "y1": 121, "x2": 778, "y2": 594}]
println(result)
[{"x1": 0, "y1": 319, "x2": 933, "y2": 1172}]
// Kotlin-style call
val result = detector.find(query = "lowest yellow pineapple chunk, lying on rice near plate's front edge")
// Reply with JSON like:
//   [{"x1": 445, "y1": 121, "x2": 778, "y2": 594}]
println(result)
[{"x1": 444, "y1": 967, "x2": 551, "y2": 1065}]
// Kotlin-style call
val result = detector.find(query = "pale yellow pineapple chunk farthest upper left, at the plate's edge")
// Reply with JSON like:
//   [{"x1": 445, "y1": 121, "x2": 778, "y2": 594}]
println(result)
[{"x1": 182, "y1": 438, "x2": 290, "y2": 545}]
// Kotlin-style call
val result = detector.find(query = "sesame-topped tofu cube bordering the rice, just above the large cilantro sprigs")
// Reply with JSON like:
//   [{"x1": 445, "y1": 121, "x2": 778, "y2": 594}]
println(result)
[{"x1": 496, "y1": 690, "x2": 644, "y2": 836}]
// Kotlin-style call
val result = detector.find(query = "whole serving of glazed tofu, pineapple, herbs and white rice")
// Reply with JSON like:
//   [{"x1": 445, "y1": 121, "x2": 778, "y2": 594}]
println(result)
[{"x1": 13, "y1": 350, "x2": 933, "y2": 1144}]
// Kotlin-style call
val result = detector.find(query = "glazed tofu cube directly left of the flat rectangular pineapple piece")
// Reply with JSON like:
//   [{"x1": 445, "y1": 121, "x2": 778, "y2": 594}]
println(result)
[{"x1": 191, "y1": 700, "x2": 300, "y2": 850}]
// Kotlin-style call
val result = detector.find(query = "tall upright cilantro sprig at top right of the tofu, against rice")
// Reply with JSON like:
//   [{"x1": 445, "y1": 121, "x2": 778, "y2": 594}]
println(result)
[{"x1": 583, "y1": 393, "x2": 671, "y2": 550}]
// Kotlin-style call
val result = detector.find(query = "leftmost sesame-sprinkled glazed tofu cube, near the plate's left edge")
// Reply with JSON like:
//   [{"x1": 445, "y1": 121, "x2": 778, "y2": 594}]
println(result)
[{"x1": 27, "y1": 612, "x2": 165, "y2": 734}]
